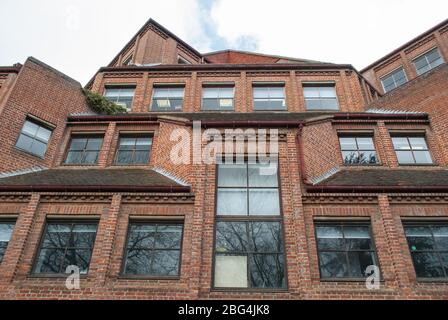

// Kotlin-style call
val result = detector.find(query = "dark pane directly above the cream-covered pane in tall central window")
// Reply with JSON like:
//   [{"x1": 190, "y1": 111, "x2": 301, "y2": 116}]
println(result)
[{"x1": 215, "y1": 222, "x2": 247, "y2": 253}]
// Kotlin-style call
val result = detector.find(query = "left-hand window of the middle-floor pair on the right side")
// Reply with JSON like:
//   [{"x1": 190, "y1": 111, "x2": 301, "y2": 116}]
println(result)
[{"x1": 339, "y1": 136, "x2": 378, "y2": 165}]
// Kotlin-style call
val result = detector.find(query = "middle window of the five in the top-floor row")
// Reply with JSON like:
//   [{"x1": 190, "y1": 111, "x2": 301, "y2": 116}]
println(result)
[{"x1": 202, "y1": 86, "x2": 233, "y2": 110}]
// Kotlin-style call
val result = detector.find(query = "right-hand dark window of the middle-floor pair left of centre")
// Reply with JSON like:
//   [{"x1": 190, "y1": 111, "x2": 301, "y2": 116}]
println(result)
[{"x1": 115, "y1": 135, "x2": 152, "y2": 164}]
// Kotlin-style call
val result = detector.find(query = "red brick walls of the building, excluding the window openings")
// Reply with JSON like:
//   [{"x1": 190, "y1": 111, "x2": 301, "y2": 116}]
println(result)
[{"x1": 0, "y1": 20, "x2": 448, "y2": 299}]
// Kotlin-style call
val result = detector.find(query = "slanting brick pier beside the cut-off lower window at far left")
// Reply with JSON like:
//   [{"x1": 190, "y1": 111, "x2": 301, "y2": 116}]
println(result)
[{"x1": 0, "y1": 194, "x2": 40, "y2": 283}]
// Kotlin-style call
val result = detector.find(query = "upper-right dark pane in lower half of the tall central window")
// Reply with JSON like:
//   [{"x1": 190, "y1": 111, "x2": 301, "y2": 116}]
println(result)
[{"x1": 249, "y1": 222, "x2": 283, "y2": 253}]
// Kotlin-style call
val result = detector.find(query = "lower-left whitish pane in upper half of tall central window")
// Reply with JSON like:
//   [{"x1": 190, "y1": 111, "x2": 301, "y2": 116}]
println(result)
[{"x1": 217, "y1": 189, "x2": 247, "y2": 215}]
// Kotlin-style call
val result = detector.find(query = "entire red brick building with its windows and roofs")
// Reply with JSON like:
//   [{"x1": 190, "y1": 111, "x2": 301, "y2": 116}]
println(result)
[{"x1": 0, "y1": 20, "x2": 448, "y2": 299}]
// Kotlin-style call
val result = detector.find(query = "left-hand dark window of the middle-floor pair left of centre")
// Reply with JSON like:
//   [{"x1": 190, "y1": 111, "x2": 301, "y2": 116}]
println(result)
[{"x1": 65, "y1": 136, "x2": 103, "y2": 164}]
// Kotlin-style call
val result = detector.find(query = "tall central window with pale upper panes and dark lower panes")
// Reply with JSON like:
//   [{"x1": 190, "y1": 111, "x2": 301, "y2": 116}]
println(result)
[{"x1": 214, "y1": 163, "x2": 286, "y2": 288}]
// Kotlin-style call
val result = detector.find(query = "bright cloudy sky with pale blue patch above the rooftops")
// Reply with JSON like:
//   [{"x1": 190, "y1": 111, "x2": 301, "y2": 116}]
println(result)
[{"x1": 0, "y1": 0, "x2": 448, "y2": 84}]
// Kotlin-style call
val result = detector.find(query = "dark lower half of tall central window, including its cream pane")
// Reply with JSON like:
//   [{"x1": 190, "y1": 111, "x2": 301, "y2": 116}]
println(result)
[{"x1": 214, "y1": 221, "x2": 286, "y2": 288}]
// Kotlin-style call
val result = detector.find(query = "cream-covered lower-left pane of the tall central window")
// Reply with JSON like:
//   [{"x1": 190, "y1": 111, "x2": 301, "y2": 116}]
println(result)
[{"x1": 214, "y1": 255, "x2": 248, "y2": 288}]
